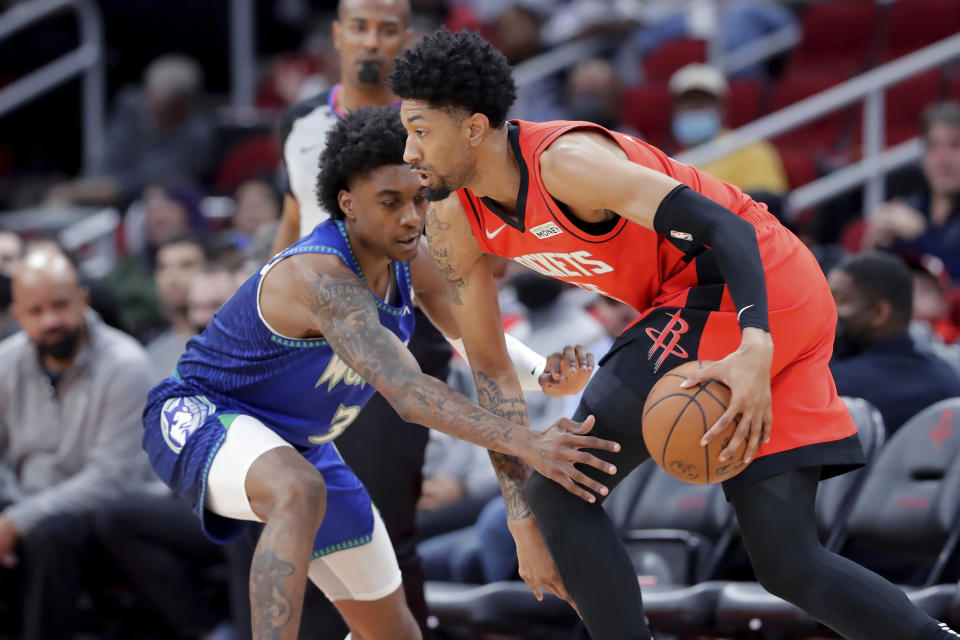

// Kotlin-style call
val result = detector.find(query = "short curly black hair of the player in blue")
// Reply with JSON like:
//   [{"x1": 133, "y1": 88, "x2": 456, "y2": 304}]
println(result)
[{"x1": 317, "y1": 107, "x2": 407, "y2": 220}]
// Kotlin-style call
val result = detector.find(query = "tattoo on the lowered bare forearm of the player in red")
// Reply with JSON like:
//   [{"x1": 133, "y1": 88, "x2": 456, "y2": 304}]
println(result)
[{"x1": 476, "y1": 371, "x2": 530, "y2": 520}]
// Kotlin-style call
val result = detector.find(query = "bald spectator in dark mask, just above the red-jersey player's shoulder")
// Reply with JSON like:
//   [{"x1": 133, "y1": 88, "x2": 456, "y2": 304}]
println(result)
[{"x1": 565, "y1": 58, "x2": 636, "y2": 135}]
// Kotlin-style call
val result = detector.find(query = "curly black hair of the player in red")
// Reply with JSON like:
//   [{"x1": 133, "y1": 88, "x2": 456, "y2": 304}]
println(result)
[{"x1": 387, "y1": 28, "x2": 517, "y2": 128}]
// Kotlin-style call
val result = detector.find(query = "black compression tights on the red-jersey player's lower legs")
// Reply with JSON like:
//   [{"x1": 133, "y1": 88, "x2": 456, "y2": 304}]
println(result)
[{"x1": 528, "y1": 440, "x2": 957, "y2": 640}]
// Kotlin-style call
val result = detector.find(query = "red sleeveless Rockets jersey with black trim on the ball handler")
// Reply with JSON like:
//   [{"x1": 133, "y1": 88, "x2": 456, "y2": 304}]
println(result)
[{"x1": 457, "y1": 120, "x2": 822, "y2": 311}]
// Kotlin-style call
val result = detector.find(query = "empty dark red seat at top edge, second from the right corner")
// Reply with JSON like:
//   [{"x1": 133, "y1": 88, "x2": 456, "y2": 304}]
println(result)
[{"x1": 790, "y1": 0, "x2": 877, "y2": 75}]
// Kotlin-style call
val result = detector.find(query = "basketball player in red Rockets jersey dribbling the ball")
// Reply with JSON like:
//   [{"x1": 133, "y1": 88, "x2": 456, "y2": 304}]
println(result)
[{"x1": 389, "y1": 30, "x2": 956, "y2": 640}]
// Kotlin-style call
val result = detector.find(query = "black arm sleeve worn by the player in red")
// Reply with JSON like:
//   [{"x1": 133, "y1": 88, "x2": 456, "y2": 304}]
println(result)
[{"x1": 653, "y1": 184, "x2": 770, "y2": 331}]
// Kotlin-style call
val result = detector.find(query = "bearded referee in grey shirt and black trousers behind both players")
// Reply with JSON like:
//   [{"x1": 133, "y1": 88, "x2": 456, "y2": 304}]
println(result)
[{"x1": 272, "y1": 0, "x2": 451, "y2": 638}]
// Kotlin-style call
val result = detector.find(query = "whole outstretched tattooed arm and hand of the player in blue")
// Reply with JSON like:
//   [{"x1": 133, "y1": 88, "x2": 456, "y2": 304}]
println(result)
[{"x1": 260, "y1": 254, "x2": 614, "y2": 493}]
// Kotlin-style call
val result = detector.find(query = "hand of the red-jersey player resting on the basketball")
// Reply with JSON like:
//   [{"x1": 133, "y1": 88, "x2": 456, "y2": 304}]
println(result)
[{"x1": 680, "y1": 327, "x2": 773, "y2": 464}]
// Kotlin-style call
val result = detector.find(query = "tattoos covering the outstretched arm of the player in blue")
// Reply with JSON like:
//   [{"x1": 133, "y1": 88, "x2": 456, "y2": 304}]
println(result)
[{"x1": 307, "y1": 273, "x2": 526, "y2": 451}]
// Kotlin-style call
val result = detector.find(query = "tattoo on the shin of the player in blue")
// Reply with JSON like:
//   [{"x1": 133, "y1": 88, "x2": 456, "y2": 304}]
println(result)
[{"x1": 250, "y1": 551, "x2": 294, "y2": 640}]
